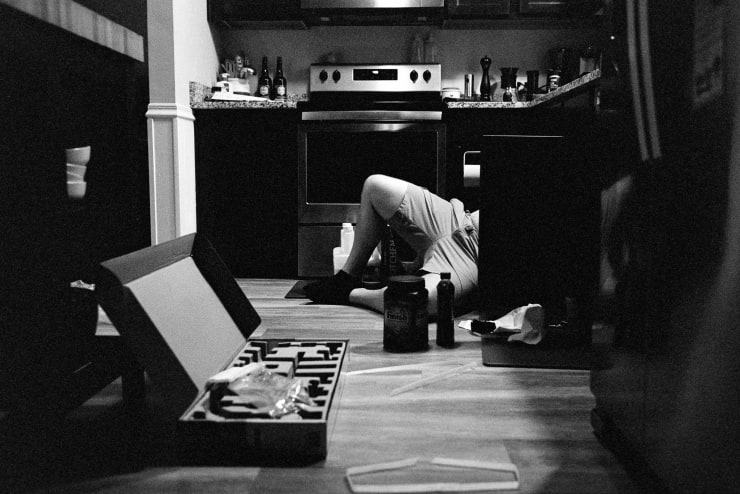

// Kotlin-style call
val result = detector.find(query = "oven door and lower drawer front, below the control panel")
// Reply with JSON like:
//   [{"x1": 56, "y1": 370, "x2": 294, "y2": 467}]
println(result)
[{"x1": 298, "y1": 120, "x2": 446, "y2": 277}]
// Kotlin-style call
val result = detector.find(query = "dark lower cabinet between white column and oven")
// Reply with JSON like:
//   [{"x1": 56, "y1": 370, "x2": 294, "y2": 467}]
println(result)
[{"x1": 194, "y1": 109, "x2": 299, "y2": 278}]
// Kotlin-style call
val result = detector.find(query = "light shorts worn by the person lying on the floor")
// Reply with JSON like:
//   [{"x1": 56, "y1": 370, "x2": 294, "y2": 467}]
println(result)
[{"x1": 388, "y1": 184, "x2": 478, "y2": 304}]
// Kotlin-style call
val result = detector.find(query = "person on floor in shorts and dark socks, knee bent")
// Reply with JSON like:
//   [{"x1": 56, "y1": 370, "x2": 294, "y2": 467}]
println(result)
[{"x1": 304, "y1": 175, "x2": 479, "y2": 315}]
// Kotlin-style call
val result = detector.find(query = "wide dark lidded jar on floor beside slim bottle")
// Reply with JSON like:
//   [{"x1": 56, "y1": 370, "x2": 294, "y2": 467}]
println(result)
[{"x1": 383, "y1": 275, "x2": 429, "y2": 352}]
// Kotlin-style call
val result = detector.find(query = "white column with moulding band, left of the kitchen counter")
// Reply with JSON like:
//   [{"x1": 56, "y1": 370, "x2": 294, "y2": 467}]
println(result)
[{"x1": 146, "y1": 0, "x2": 218, "y2": 244}]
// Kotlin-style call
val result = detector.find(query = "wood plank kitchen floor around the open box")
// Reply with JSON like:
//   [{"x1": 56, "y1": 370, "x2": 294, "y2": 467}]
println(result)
[{"x1": 0, "y1": 280, "x2": 640, "y2": 494}]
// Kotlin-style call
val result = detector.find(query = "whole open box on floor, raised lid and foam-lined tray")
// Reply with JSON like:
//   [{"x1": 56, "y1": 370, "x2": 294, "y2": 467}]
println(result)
[{"x1": 95, "y1": 233, "x2": 348, "y2": 465}]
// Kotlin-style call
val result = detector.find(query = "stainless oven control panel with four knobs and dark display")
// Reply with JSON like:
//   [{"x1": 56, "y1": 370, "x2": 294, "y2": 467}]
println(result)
[{"x1": 309, "y1": 63, "x2": 442, "y2": 92}]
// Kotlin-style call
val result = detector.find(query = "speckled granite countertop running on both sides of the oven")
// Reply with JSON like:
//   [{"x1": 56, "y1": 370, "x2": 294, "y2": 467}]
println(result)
[{"x1": 190, "y1": 69, "x2": 601, "y2": 110}]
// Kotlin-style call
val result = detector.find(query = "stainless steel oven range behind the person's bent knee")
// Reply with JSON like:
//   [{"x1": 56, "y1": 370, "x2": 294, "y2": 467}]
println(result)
[{"x1": 298, "y1": 64, "x2": 446, "y2": 277}]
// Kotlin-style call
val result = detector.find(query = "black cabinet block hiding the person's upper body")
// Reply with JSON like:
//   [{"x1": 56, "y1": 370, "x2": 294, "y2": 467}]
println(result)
[{"x1": 471, "y1": 109, "x2": 601, "y2": 332}]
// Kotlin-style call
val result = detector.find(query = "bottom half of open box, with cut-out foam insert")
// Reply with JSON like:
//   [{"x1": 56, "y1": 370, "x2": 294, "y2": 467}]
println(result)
[{"x1": 177, "y1": 340, "x2": 347, "y2": 464}]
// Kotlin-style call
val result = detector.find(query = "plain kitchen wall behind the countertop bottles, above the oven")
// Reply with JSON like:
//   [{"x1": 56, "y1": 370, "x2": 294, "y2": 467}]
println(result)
[{"x1": 217, "y1": 26, "x2": 598, "y2": 94}]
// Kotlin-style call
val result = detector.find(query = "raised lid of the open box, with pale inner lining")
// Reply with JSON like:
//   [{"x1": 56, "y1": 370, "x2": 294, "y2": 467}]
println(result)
[{"x1": 96, "y1": 233, "x2": 261, "y2": 416}]
